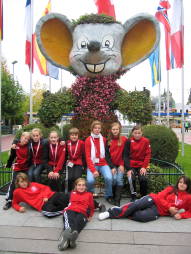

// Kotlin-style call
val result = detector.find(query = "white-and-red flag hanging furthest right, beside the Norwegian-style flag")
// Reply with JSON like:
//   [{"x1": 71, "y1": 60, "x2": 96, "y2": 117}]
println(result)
[{"x1": 171, "y1": 0, "x2": 184, "y2": 68}]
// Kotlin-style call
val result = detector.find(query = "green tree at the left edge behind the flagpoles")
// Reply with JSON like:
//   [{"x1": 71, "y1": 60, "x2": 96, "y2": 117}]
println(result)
[{"x1": 1, "y1": 64, "x2": 25, "y2": 124}]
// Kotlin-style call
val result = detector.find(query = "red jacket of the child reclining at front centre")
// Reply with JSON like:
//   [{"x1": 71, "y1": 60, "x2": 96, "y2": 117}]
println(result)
[{"x1": 65, "y1": 191, "x2": 94, "y2": 217}]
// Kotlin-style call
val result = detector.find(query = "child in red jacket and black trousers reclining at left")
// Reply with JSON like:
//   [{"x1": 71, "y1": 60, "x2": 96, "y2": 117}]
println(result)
[{"x1": 12, "y1": 173, "x2": 69, "y2": 218}]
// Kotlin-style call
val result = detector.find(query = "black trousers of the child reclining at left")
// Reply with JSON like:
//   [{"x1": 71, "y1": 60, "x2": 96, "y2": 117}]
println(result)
[{"x1": 42, "y1": 192, "x2": 69, "y2": 217}]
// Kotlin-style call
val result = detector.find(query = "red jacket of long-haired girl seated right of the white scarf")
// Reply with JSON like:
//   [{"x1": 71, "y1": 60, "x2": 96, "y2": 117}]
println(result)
[{"x1": 106, "y1": 136, "x2": 127, "y2": 169}]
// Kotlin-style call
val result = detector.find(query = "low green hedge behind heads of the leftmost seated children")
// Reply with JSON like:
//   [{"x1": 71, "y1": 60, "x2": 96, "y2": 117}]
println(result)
[{"x1": 15, "y1": 123, "x2": 61, "y2": 139}]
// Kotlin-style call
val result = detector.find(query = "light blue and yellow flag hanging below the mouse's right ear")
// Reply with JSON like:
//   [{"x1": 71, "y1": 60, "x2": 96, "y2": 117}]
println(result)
[{"x1": 149, "y1": 47, "x2": 161, "y2": 86}]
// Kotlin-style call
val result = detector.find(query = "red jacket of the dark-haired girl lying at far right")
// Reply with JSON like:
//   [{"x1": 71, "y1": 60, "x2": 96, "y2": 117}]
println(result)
[{"x1": 149, "y1": 186, "x2": 191, "y2": 219}]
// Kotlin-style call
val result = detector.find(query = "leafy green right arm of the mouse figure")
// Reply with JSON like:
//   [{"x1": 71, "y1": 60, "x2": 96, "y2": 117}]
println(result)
[{"x1": 113, "y1": 89, "x2": 152, "y2": 125}]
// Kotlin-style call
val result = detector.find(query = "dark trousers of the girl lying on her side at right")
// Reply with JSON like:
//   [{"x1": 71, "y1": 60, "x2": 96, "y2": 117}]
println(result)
[{"x1": 108, "y1": 196, "x2": 159, "y2": 222}]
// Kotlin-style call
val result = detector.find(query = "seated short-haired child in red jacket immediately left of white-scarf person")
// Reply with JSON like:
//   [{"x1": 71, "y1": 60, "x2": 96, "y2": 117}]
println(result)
[{"x1": 66, "y1": 128, "x2": 85, "y2": 192}]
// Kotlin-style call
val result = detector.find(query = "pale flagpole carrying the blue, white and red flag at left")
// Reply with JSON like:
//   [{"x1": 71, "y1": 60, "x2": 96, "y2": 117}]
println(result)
[{"x1": 29, "y1": 0, "x2": 33, "y2": 124}]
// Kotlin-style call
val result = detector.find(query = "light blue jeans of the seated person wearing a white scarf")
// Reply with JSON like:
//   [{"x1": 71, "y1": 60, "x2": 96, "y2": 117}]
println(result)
[{"x1": 87, "y1": 165, "x2": 113, "y2": 198}]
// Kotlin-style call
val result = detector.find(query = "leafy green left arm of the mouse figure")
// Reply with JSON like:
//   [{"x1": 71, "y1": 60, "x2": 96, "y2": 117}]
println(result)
[{"x1": 38, "y1": 89, "x2": 74, "y2": 127}]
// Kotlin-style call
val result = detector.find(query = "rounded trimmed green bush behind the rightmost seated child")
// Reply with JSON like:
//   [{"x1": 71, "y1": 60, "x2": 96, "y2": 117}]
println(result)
[{"x1": 143, "y1": 125, "x2": 179, "y2": 163}]
